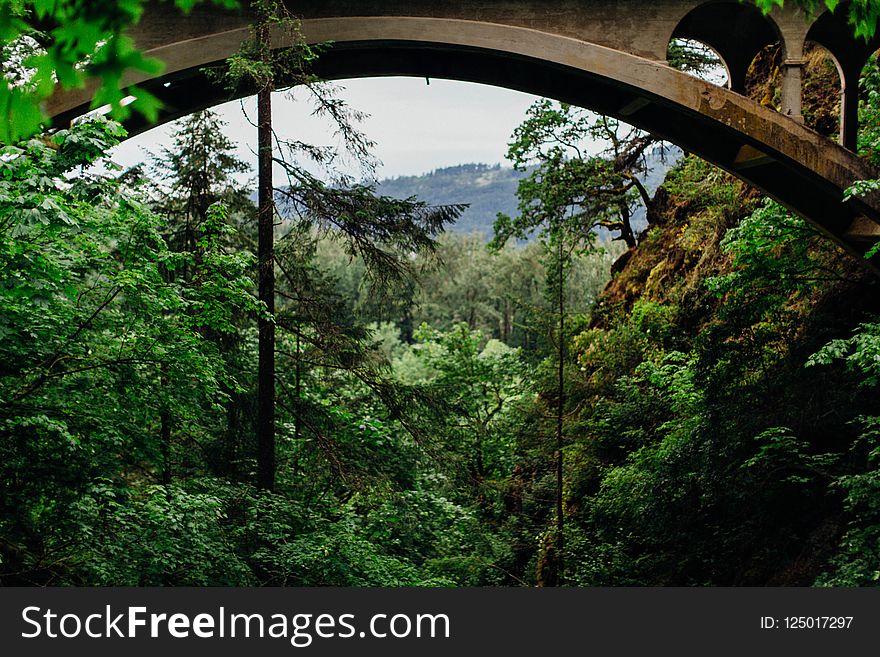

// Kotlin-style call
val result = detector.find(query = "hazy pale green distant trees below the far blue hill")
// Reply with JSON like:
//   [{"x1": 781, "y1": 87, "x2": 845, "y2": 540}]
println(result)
[{"x1": 316, "y1": 233, "x2": 619, "y2": 361}]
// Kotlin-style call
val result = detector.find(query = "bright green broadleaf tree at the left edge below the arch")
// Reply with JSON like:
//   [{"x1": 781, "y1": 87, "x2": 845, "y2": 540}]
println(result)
[{"x1": 0, "y1": 120, "x2": 254, "y2": 579}]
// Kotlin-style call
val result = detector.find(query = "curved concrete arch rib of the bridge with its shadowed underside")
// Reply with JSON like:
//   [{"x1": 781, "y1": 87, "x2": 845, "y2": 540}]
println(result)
[{"x1": 49, "y1": 25, "x2": 880, "y2": 269}]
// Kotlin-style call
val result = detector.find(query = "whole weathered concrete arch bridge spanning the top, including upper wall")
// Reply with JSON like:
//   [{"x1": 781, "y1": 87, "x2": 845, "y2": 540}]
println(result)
[{"x1": 49, "y1": 0, "x2": 880, "y2": 264}]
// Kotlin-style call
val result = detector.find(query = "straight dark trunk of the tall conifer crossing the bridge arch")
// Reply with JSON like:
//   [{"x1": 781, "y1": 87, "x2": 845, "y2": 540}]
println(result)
[{"x1": 257, "y1": 32, "x2": 275, "y2": 490}]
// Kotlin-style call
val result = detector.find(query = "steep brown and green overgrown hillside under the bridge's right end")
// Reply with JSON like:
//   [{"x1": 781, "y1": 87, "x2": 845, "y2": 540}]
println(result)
[{"x1": 552, "y1": 157, "x2": 880, "y2": 585}]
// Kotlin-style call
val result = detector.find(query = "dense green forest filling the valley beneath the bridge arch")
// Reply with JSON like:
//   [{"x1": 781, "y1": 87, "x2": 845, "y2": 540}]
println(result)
[{"x1": 0, "y1": 0, "x2": 880, "y2": 586}]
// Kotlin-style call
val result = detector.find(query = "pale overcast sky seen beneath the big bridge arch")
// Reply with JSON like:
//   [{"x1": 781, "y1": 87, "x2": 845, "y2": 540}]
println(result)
[{"x1": 113, "y1": 78, "x2": 536, "y2": 178}]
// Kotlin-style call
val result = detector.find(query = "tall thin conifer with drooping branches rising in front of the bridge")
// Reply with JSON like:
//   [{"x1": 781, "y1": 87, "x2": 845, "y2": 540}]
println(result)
[{"x1": 211, "y1": 0, "x2": 464, "y2": 490}]
